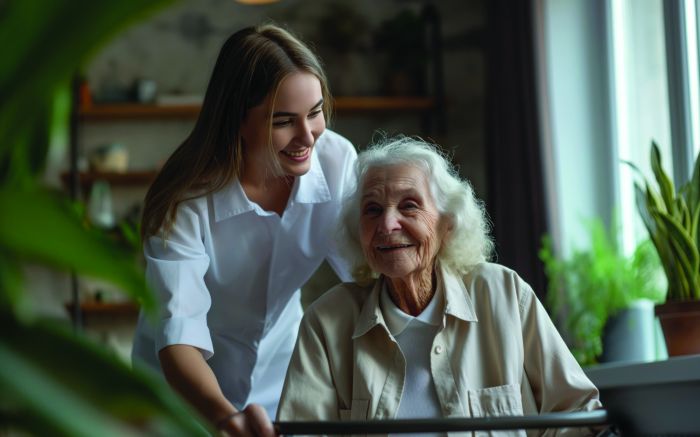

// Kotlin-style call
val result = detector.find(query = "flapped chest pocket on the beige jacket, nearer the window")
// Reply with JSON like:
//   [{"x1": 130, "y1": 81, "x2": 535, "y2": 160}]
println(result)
[{"x1": 468, "y1": 384, "x2": 526, "y2": 437}]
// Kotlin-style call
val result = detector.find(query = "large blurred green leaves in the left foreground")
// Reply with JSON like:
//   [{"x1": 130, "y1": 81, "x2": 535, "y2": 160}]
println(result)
[{"x1": 0, "y1": 0, "x2": 211, "y2": 436}]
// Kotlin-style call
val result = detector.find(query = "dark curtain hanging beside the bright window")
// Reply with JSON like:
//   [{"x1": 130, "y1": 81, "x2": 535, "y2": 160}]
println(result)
[{"x1": 484, "y1": 0, "x2": 547, "y2": 298}]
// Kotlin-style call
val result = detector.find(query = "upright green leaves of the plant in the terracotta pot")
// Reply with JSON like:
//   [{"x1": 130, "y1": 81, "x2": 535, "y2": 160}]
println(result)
[{"x1": 628, "y1": 142, "x2": 700, "y2": 301}]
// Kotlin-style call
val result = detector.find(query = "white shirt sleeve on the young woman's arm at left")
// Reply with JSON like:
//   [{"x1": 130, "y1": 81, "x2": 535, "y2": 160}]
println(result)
[{"x1": 144, "y1": 204, "x2": 214, "y2": 359}]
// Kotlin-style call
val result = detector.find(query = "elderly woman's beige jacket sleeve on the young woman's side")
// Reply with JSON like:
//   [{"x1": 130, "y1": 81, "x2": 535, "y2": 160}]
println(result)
[{"x1": 277, "y1": 304, "x2": 339, "y2": 421}]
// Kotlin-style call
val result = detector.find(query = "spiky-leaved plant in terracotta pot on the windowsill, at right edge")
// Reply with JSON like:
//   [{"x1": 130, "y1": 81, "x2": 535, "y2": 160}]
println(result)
[{"x1": 628, "y1": 142, "x2": 700, "y2": 356}]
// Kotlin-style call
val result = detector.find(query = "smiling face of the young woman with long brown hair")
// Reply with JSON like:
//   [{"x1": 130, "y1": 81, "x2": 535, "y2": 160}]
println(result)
[{"x1": 241, "y1": 72, "x2": 326, "y2": 178}]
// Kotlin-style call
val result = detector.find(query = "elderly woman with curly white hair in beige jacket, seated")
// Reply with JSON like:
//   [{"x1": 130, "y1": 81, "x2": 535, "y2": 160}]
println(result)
[{"x1": 278, "y1": 137, "x2": 601, "y2": 434}]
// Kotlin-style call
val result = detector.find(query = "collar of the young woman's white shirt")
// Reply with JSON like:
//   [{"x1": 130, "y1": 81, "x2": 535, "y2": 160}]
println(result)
[{"x1": 212, "y1": 146, "x2": 331, "y2": 222}]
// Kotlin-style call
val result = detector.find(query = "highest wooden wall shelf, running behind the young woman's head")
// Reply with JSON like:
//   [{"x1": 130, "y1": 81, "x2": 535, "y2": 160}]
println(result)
[{"x1": 78, "y1": 96, "x2": 435, "y2": 120}]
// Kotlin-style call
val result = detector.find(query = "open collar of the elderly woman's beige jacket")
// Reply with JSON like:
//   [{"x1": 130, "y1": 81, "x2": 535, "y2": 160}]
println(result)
[{"x1": 352, "y1": 267, "x2": 478, "y2": 339}]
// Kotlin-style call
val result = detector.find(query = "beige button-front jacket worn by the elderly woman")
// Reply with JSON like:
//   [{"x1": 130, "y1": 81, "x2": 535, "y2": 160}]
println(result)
[{"x1": 277, "y1": 263, "x2": 601, "y2": 435}]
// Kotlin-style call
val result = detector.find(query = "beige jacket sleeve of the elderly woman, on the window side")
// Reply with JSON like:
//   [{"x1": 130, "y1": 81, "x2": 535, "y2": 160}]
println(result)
[{"x1": 518, "y1": 278, "x2": 601, "y2": 435}]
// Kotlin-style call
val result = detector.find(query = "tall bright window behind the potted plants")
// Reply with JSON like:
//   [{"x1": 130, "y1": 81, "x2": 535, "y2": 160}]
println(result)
[{"x1": 536, "y1": 0, "x2": 700, "y2": 255}]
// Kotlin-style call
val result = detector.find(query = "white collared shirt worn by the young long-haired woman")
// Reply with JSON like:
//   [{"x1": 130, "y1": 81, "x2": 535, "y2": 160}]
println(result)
[{"x1": 132, "y1": 130, "x2": 357, "y2": 417}]
